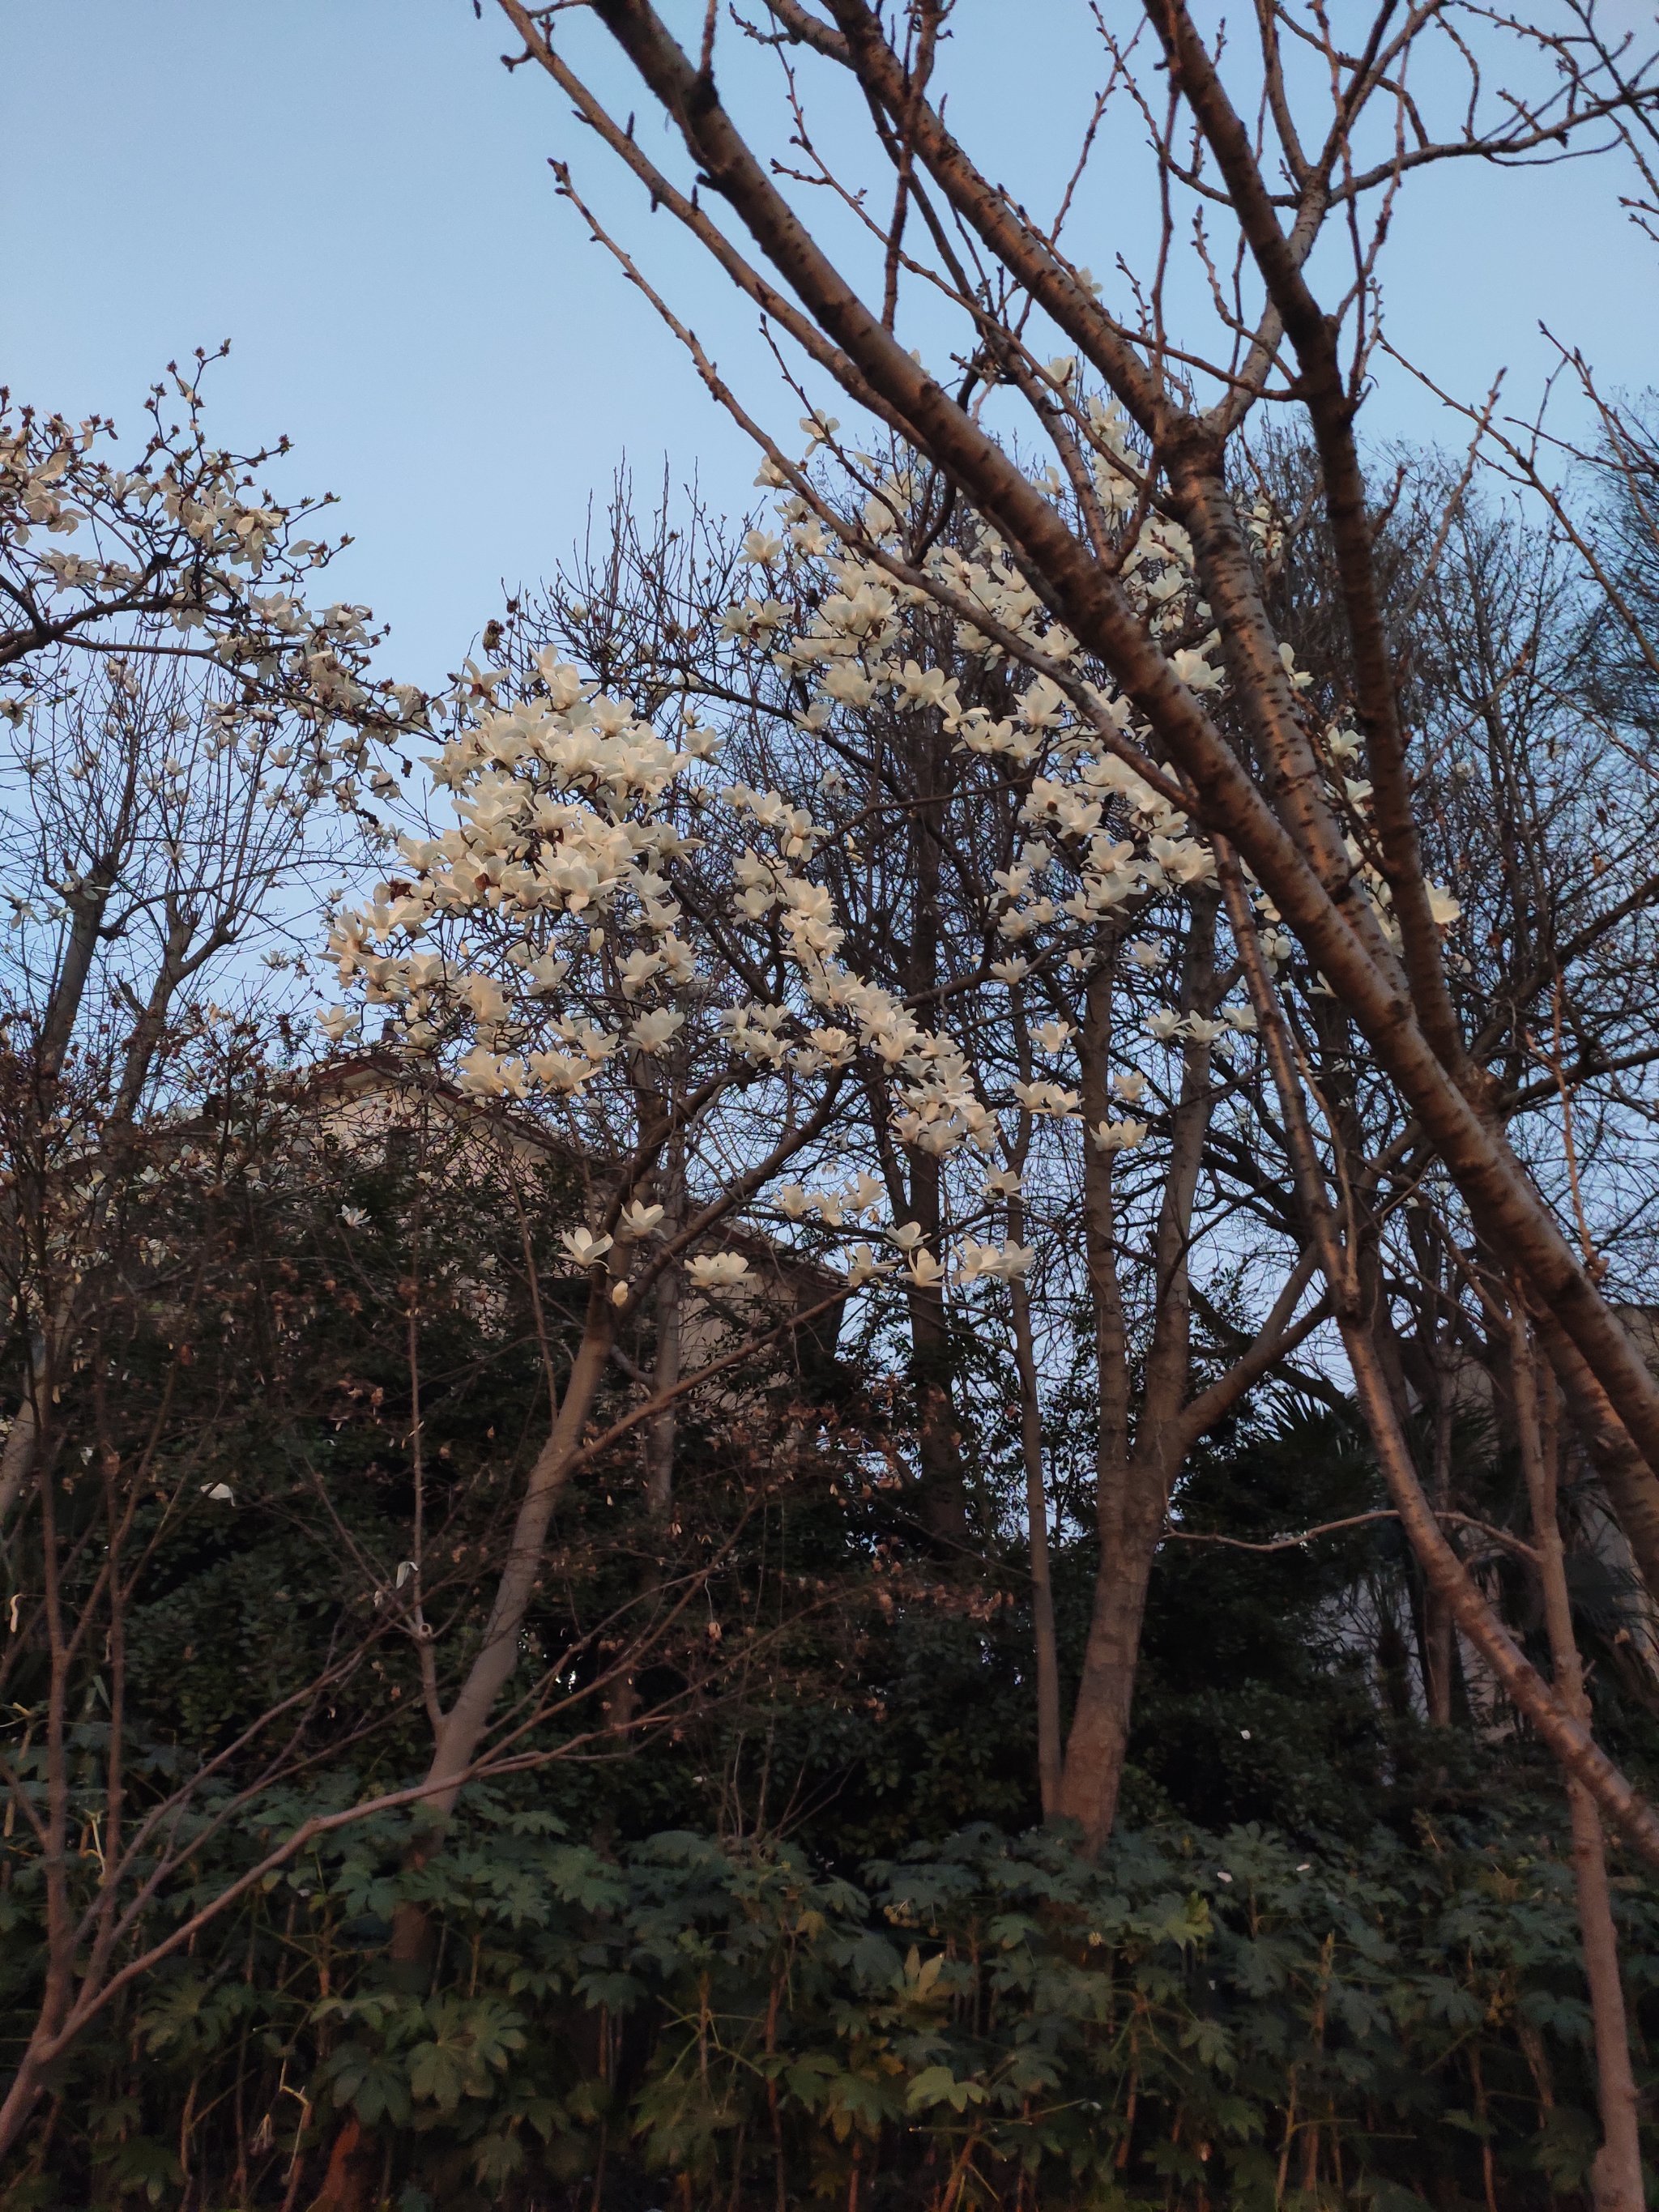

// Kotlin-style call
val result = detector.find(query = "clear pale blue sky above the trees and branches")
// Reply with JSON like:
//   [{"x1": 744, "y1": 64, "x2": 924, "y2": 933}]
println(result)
[{"x1": 13, "y1": 0, "x2": 1659, "y2": 681}]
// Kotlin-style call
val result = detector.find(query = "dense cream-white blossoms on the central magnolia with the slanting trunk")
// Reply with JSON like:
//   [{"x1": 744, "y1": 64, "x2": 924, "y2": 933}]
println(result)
[{"x1": 323, "y1": 654, "x2": 1039, "y2": 1287}]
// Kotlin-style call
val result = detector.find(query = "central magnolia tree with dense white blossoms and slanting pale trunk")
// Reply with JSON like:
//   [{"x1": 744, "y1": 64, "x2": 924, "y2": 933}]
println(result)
[{"x1": 325, "y1": 543, "x2": 1030, "y2": 1858}]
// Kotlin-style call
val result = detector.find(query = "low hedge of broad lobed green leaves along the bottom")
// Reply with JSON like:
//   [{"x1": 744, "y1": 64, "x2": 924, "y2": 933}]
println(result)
[{"x1": 4, "y1": 1798, "x2": 1659, "y2": 2212}]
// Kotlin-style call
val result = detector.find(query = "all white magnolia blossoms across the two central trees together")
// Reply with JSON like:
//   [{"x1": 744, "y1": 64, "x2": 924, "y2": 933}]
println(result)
[{"x1": 325, "y1": 395, "x2": 1433, "y2": 1289}]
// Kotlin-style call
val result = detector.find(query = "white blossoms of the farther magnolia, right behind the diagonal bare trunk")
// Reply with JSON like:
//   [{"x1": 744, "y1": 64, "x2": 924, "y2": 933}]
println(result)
[{"x1": 726, "y1": 424, "x2": 1282, "y2": 1153}]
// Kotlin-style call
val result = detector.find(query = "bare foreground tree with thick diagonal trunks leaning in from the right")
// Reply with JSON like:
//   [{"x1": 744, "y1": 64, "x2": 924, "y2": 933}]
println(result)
[{"x1": 468, "y1": 0, "x2": 1659, "y2": 2203}]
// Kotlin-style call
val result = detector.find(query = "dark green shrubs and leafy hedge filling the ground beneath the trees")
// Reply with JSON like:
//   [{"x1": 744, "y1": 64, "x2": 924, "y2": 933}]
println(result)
[{"x1": 0, "y1": 1079, "x2": 1659, "y2": 2212}]
